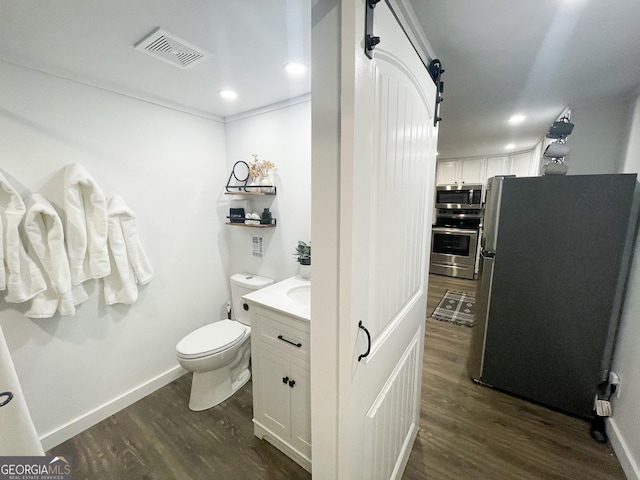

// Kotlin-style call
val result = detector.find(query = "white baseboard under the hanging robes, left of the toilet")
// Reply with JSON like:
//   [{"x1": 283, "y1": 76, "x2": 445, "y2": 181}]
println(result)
[{"x1": 40, "y1": 365, "x2": 187, "y2": 452}]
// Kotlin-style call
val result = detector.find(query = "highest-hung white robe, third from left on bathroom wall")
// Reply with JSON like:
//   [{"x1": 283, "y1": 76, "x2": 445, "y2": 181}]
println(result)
[{"x1": 64, "y1": 163, "x2": 110, "y2": 285}]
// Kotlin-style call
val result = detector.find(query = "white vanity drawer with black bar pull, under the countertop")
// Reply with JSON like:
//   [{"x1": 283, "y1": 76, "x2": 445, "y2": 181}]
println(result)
[{"x1": 251, "y1": 312, "x2": 309, "y2": 360}]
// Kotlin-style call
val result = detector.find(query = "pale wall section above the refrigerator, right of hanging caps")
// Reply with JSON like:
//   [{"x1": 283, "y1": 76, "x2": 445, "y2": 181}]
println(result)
[{"x1": 566, "y1": 96, "x2": 629, "y2": 175}]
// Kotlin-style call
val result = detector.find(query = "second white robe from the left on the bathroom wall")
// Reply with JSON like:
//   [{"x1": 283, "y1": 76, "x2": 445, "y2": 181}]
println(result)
[{"x1": 24, "y1": 193, "x2": 76, "y2": 318}]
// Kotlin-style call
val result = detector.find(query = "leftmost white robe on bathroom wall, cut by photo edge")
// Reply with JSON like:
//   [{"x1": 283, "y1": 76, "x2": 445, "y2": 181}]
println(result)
[{"x1": 0, "y1": 173, "x2": 47, "y2": 303}]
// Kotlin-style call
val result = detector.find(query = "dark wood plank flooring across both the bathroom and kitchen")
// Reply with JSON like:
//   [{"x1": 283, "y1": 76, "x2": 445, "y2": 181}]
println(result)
[{"x1": 48, "y1": 275, "x2": 625, "y2": 480}]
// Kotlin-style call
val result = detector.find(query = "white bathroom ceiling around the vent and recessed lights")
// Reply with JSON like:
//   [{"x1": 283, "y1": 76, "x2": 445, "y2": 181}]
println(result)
[{"x1": 0, "y1": 0, "x2": 311, "y2": 117}]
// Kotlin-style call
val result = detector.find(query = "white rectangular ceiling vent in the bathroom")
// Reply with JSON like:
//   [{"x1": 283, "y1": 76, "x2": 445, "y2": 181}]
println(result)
[{"x1": 135, "y1": 28, "x2": 211, "y2": 68}]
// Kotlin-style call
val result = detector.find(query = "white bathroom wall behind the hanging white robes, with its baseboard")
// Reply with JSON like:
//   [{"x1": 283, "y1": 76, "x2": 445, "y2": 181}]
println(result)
[{"x1": 0, "y1": 62, "x2": 230, "y2": 448}]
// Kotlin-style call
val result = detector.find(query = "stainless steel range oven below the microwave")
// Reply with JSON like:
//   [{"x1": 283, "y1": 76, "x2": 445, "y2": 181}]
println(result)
[{"x1": 429, "y1": 209, "x2": 482, "y2": 279}]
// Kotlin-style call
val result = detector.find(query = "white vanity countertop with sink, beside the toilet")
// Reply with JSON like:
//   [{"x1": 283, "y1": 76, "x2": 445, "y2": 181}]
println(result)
[{"x1": 242, "y1": 276, "x2": 311, "y2": 321}]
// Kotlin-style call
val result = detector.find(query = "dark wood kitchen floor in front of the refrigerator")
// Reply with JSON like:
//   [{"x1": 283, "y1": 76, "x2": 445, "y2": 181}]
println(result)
[{"x1": 402, "y1": 275, "x2": 625, "y2": 480}]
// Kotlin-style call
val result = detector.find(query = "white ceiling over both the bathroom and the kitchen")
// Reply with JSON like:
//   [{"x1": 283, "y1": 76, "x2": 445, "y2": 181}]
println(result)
[{"x1": 0, "y1": 0, "x2": 640, "y2": 158}]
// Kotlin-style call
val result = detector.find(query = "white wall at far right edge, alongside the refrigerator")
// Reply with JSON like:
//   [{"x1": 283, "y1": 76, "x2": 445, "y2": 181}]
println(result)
[{"x1": 609, "y1": 97, "x2": 640, "y2": 479}]
